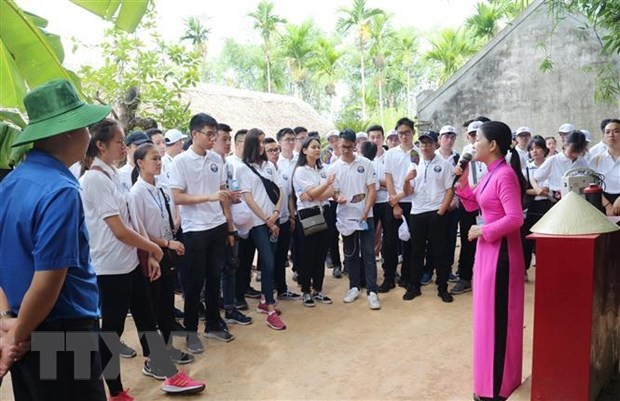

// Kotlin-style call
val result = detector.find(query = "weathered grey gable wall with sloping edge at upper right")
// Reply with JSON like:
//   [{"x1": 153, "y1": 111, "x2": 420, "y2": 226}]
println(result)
[{"x1": 417, "y1": 1, "x2": 620, "y2": 149}]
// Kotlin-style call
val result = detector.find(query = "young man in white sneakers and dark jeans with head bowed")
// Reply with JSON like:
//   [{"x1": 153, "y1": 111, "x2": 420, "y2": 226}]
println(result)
[{"x1": 328, "y1": 130, "x2": 381, "y2": 310}]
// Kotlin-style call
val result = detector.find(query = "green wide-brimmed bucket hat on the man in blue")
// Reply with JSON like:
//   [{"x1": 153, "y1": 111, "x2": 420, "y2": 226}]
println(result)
[{"x1": 13, "y1": 79, "x2": 111, "y2": 147}]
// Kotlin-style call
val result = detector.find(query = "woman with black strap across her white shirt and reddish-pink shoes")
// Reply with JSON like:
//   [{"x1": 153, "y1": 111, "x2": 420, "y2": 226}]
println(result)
[{"x1": 236, "y1": 128, "x2": 286, "y2": 330}]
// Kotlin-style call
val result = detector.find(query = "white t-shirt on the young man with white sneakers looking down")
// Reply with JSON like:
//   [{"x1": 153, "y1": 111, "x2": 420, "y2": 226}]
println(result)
[{"x1": 327, "y1": 155, "x2": 379, "y2": 223}]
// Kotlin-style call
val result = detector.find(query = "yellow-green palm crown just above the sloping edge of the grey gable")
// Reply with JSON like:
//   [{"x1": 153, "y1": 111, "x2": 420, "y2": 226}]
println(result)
[{"x1": 424, "y1": 28, "x2": 478, "y2": 85}]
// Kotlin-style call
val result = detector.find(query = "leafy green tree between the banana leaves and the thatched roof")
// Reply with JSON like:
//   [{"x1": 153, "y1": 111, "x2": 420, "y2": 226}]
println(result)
[{"x1": 80, "y1": 12, "x2": 201, "y2": 129}]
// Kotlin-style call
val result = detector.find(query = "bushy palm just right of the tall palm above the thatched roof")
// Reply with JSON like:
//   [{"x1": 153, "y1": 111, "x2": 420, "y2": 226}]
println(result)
[{"x1": 279, "y1": 20, "x2": 317, "y2": 98}]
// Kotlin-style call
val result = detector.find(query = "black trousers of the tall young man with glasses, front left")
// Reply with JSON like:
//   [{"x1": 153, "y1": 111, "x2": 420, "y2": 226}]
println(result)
[{"x1": 184, "y1": 223, "x2": 227, "y2": 332}]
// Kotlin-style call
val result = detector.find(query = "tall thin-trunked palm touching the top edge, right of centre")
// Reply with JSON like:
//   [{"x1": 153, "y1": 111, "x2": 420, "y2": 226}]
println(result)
[{"x1": 337, "y1": 0, "x2": 384, "y2": 120}]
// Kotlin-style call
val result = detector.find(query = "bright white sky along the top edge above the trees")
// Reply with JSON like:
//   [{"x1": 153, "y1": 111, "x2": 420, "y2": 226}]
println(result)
[{"x1": 15, "y1": 0, "x2": 481, "y2": 68}]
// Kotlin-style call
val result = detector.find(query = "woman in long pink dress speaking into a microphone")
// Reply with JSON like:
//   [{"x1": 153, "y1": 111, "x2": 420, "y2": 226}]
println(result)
[{"x1": 454, "y1": 121, "x2": 525, "y2": 401}]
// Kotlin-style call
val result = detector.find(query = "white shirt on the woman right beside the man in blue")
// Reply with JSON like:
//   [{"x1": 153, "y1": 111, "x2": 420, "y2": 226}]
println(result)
[{"x1": 80, "y1": 158, "x2": 138, "y2": 276}]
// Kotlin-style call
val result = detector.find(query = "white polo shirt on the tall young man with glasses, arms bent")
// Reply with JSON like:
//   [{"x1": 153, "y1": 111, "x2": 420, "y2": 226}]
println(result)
[{"x1": 169, "y1": 147, "x2": 226, "y2": 232}]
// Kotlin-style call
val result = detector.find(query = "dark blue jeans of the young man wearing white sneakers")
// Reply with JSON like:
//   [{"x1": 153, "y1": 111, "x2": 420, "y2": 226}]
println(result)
[{"x1": 343, "y1": 219, "x2": 377, "y2": 293}]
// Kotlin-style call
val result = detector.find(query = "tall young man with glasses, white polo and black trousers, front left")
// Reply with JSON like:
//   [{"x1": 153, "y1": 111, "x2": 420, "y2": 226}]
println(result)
[{"x1": 169, "y1": 113, "x2": 235, "y2": 353}]
